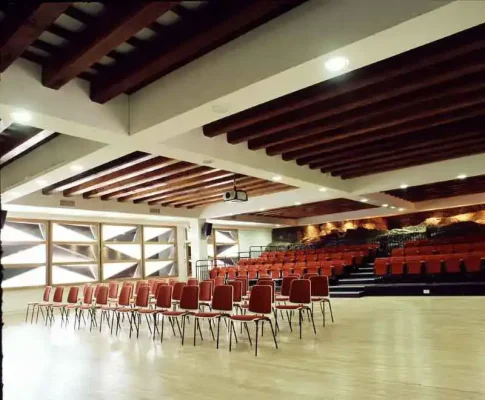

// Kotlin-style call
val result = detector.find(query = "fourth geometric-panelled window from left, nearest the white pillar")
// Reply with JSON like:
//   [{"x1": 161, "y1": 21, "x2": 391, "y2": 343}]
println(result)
[{"x1": 143, "y1": 226, "x2": 178, "y2": 278}]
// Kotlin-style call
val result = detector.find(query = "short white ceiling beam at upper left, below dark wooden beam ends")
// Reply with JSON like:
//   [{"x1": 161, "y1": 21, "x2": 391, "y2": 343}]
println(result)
[{"x1": 0, "y1": 59, "x2": 129, "y2": 143}]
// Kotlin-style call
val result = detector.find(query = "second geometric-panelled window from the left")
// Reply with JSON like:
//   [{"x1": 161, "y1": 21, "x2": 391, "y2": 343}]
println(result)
[{"x1": 51, "y1": 222, "x2": 99, "y2": 285}]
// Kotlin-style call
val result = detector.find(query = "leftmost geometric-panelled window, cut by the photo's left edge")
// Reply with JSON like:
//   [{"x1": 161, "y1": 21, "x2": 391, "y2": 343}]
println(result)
[{"x1": 1, "y1": 220, "x2": 47, "y2": 288}]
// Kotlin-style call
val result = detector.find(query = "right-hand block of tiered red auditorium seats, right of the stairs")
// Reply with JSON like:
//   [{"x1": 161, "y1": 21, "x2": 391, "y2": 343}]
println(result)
[{"x1": 374, "y1": 238, "x2": 485, "y2": 280}]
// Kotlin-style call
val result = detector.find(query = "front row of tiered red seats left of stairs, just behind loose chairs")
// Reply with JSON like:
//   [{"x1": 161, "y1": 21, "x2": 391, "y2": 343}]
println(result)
[{"x1": 209, "y1": 260, "x2": 352, "y2": 279}]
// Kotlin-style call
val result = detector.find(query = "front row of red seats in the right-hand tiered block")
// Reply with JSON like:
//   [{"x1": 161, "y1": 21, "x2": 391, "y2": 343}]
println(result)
[{"x1": 374, "y1": 253, "x2": 485, "y2": 276}]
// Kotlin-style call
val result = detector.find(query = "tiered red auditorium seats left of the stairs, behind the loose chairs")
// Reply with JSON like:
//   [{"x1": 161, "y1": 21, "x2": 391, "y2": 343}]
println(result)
[{"x1": 210, "y1": 244, "x2": 378, "y2": 279}]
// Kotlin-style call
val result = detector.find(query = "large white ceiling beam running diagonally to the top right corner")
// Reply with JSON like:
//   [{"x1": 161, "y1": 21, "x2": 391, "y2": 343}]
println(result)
[{"x1": 125, "y1": 0, "x2": 485, "y2": 140}]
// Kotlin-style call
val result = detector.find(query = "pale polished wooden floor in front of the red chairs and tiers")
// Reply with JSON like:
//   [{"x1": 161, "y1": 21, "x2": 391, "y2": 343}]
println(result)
[{"x1": 3, "y1": 297, "x2": 485, "y2": 400}]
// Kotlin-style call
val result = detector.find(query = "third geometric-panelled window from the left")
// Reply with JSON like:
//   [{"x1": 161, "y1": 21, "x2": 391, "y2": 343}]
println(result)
[{"x1": 102, "y1": 224, "x2": 142, "y2": 279}]
